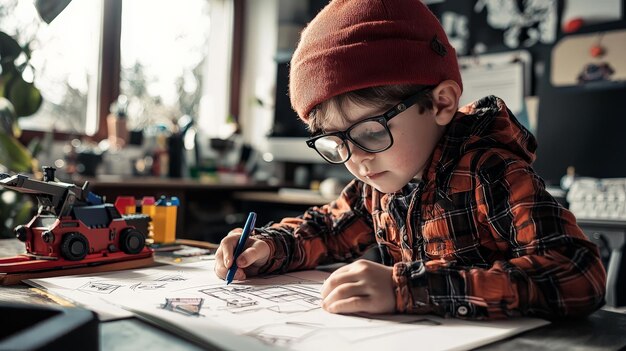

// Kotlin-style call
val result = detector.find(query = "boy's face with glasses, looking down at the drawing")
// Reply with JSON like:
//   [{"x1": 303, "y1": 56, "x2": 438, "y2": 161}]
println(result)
[{"x1": 324, "y1": 101, "x2": 445, "y2": 193}]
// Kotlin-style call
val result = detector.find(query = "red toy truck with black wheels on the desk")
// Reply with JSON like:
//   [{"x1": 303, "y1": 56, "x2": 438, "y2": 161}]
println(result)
[{"x1": 0, "y1": 167, "x2": 152, "y2": 273}]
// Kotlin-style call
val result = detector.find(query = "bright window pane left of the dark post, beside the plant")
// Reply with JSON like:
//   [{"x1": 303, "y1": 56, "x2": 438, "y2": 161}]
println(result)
[{"x1": 0, "y1": 0, "x2": 102, "y2": 134}]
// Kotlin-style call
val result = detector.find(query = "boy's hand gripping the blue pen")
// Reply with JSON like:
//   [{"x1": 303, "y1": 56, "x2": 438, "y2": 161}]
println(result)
[{"x1": 215, "y1": 228, "x2": 270, "y2": 280}]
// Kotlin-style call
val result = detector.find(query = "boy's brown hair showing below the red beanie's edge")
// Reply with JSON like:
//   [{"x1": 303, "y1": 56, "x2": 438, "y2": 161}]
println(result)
[{"x1": 306, "y1": 84, "x2": 433, "y2": 135}]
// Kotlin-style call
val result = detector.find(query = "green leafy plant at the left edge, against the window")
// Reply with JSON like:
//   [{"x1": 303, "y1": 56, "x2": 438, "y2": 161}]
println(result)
[{"x1": 0, "y1": 0, "x2": 70, "y2": 238}]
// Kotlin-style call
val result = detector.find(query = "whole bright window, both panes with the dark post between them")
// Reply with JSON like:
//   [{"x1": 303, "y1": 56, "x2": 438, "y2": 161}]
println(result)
[{"x1": 0, "y1": 0, "x2": 235, "y2": 138}]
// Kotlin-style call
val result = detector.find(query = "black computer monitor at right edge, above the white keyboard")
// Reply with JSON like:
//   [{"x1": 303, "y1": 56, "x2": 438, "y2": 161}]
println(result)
[{"x1": 534, "y1": 86, "x2": 626, "y2": 185}]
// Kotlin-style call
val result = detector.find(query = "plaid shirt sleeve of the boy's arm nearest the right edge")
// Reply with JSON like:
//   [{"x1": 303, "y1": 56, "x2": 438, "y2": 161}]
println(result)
[{"x1": 394, "y1": 153, "x2": 606, "y2": 319}]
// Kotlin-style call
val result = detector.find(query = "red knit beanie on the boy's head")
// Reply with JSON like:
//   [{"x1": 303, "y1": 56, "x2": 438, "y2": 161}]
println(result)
[{"x1": 289, "y1": 0, "x2": 463, "y2": 121}]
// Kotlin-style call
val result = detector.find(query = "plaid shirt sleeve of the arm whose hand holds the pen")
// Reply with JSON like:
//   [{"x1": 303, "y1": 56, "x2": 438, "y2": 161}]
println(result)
[{"x1": 254, "y1": 180, "x2": 375, "y2": 273}]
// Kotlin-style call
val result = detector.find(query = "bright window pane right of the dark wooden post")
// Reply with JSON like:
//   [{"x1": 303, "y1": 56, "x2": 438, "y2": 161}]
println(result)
[{"x1": 120, "y1": 0, "x2": 211, "y2": 133}]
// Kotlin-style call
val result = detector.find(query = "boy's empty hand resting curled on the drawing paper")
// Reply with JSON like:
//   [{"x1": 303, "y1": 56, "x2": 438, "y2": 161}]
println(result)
[{"x1": 322, "y1": 260, "x2": 396, "y2": 313}]
